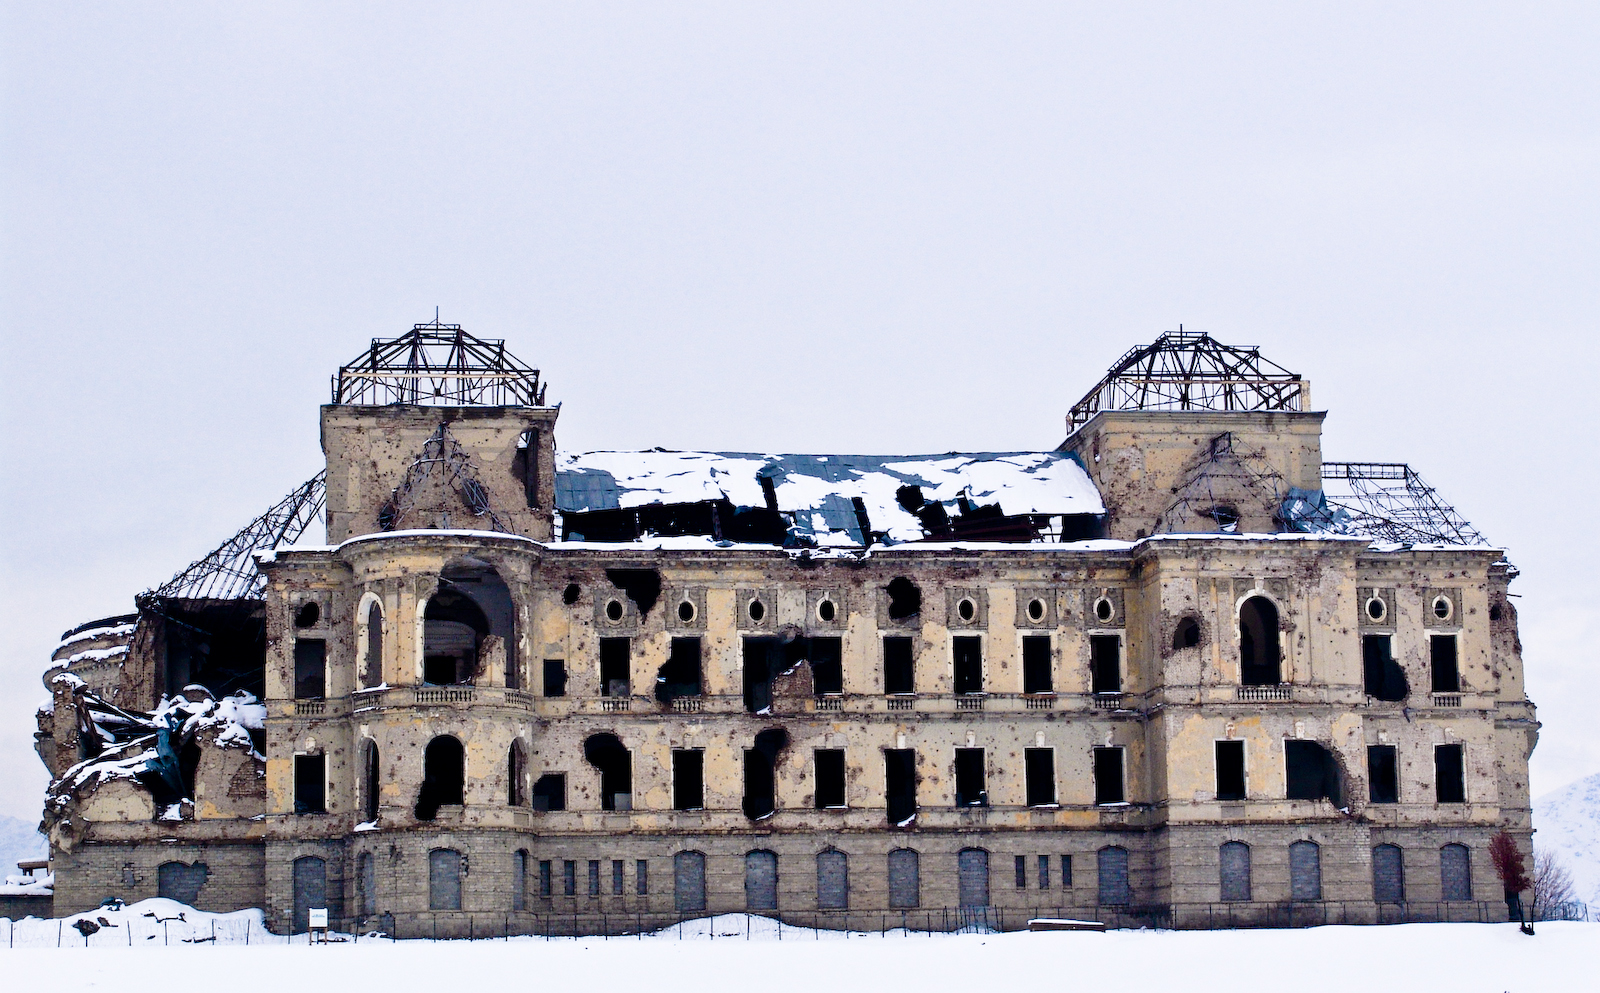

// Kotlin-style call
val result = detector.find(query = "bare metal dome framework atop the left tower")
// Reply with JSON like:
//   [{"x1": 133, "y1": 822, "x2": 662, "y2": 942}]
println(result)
[{"x1": 333, "y1": 320, "x2": 544, "y2": 406}]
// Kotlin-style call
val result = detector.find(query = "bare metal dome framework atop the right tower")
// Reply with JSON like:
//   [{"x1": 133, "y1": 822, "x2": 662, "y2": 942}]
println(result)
[{"x1": 1067, "y1": 331, "x2": 1307, "y2": 433}]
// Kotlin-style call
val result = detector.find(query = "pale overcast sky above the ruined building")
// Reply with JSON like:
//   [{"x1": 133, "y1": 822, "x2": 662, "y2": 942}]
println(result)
[{"x1": 0, "y1": 0, "x2": 1600, "y2": 819}]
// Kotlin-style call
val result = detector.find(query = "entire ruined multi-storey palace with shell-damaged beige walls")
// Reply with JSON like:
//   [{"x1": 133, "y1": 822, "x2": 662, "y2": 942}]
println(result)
[{"x1": 38, "y1": 323, "x2": 1538, "y2": 935}]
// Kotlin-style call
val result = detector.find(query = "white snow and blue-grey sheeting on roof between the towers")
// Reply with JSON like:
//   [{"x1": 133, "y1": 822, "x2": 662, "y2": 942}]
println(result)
[{"x1": 555, "y1": 449, "x2": 1106, "y2": 540}]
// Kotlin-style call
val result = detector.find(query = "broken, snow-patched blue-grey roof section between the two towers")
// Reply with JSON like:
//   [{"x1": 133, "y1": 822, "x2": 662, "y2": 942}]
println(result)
[{"x1": 555, "y1": 449, "x2": 1106, "y2": 547}]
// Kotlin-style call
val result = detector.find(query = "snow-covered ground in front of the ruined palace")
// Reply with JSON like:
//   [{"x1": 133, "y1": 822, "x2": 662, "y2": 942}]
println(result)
[{"x1": 0, "y1": 900, "x2": 1600, "y2": 993}]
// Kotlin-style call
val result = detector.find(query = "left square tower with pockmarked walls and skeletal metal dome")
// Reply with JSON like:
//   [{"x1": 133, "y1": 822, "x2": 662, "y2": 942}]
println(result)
[{"x1": 322, "y1": 321, "x2": 560, "y2": 544}]
